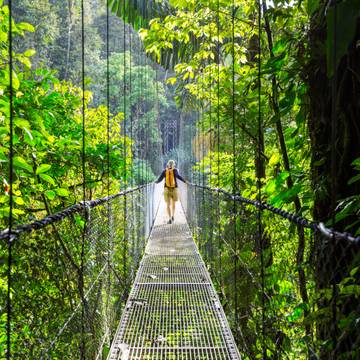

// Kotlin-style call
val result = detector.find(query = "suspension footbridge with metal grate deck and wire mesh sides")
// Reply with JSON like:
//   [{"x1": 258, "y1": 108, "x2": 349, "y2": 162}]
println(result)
[{"x1": 1, "y1": 179, "x2": 359, "y2": 360}]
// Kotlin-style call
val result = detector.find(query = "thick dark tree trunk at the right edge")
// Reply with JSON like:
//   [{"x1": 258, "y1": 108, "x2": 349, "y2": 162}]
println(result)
[{"x1": 305, "y1": 4, "x2": 360, "y2": 359}]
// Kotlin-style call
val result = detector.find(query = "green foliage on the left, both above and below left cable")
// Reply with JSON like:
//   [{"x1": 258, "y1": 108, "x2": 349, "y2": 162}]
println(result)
[{"x1": 0, "y1": 7, "x2": 156, "y2": 359}]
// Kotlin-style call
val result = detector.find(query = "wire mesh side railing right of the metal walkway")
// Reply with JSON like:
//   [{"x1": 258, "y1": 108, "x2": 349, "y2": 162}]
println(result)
[{"x1": 182, "y1": 186, "x2": 360, "y2": 359}]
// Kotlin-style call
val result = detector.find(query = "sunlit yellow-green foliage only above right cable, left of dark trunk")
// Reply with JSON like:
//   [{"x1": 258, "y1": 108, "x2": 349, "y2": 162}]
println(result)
[{"x1": 140, "y1": 0, "x2": 310, "y2": 209}]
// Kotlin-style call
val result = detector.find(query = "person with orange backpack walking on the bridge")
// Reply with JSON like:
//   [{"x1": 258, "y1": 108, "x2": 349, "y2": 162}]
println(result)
[{"x1": 155, "y1": 160, "x2": 189, "y2": 224}]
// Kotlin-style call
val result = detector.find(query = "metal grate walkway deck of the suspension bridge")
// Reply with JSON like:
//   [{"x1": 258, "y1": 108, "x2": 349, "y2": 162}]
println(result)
[{"x1": 108, "y1": 202, "x2": 240, "y2": 360}]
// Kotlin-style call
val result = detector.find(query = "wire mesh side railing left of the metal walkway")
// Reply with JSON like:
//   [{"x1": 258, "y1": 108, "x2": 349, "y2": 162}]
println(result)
[{"x1": 0, "y1": 185, "x2": 157, "y2": 359}]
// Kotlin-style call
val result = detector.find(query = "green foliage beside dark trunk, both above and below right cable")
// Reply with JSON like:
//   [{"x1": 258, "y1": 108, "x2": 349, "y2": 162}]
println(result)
[{"x1": 136, "y1": 0, "x2": 359, "y2": 359}]
